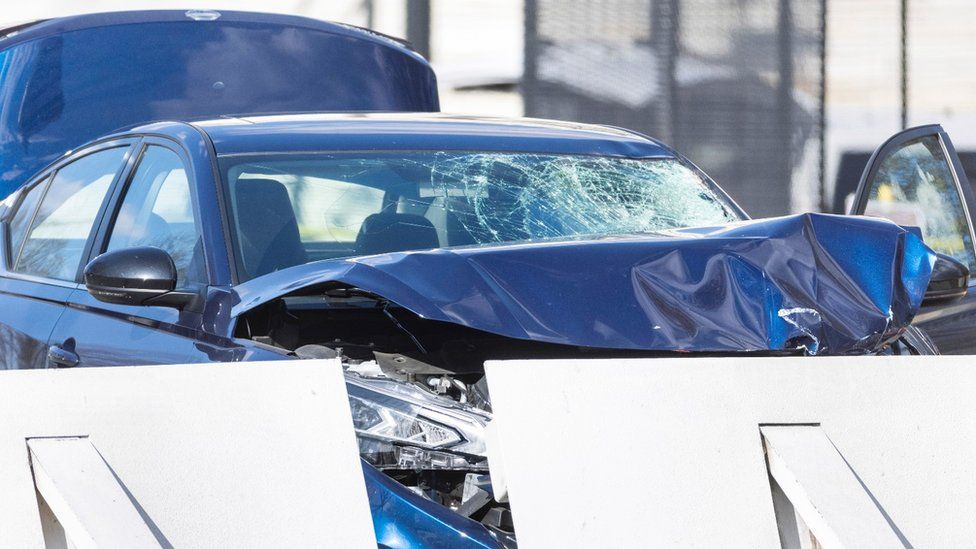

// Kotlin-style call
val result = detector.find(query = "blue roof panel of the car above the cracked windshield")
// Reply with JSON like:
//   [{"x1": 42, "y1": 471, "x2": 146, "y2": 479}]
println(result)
[{"x1": 173, "y1": 113, "x2": 675, "y2": 158}]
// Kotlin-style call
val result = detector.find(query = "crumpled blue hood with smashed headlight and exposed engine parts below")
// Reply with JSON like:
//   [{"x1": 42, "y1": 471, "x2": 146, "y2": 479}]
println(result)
[{"x1": 234, "y1": 210, "x2": 935, "y2": 546}]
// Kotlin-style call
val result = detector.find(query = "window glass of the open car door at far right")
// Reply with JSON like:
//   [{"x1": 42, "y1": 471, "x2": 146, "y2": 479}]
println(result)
[{"x1": 864, "y1": 135, "x2": 976, "y2": 273}]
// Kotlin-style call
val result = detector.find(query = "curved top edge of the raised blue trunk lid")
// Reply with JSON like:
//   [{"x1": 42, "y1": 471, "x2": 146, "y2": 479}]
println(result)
[{"x1": 0, "y1": 9, "x2": 423, "y2": 59}]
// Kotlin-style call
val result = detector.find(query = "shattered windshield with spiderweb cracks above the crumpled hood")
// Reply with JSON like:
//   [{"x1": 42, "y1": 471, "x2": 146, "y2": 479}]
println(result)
[{"x1": 221, "y1": 152, "x2": 739, "y2": 280}]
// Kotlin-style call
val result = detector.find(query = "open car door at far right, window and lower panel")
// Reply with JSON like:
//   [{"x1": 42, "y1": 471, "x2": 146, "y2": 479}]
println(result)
[{"x1": 851, "y1": 125, "x2": 976, "y2": 354}]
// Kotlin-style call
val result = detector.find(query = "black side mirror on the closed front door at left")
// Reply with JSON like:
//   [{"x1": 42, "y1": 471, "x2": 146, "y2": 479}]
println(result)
[{"x1": 85, "y1": 246, "x2": 199, "y2": 309}]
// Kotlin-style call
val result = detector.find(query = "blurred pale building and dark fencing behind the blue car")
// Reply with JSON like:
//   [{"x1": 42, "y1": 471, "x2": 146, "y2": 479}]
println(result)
[{"x1": 3, "y1": 0, "x2": 976, "y2": 217}]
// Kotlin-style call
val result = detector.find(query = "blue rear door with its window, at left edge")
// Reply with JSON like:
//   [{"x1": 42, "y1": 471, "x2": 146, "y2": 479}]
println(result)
[{"x1": 0, "y1": 141, "x2": 131, "y2": 369}]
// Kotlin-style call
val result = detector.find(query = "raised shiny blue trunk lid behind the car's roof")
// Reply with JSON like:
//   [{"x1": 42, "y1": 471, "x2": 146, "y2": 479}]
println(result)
[{"x1": 0, "y1": 10, "x2": 439, "y2": 198}]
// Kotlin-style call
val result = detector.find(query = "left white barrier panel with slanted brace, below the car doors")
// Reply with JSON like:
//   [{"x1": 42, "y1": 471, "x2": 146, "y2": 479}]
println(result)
[{"x1": 0, "y1": 360, "x2": 376, "y2": 549}]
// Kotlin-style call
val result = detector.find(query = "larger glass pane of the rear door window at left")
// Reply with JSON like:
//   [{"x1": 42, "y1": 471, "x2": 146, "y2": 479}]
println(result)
[{"x1": 14, "y1": 147, "x2": 128, "y2": 281}]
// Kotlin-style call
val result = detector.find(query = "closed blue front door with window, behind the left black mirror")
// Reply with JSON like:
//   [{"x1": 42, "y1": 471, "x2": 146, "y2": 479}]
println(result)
[{"x1": 51, "y1": 138, "x2": 240, "y2": 366}]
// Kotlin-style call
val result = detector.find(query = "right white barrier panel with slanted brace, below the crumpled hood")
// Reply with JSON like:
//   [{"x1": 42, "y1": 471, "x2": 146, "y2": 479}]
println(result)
[{"x1": 487, "y1": 356, "x2": 976, "y2": 549}]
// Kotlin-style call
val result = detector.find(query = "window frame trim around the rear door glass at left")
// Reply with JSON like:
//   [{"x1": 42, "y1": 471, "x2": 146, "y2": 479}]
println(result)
[{"x1": 2, "y1": 137, "x2": 138, "y2": 288}]
